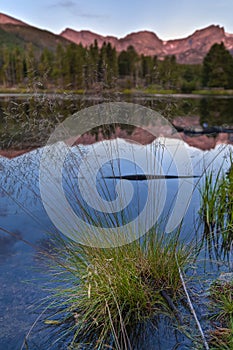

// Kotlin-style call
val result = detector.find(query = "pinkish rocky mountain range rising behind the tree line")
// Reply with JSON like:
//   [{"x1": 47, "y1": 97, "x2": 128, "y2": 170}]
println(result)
[{"x1": 0, "y1": 13, "x2": 233, "y2": 64}]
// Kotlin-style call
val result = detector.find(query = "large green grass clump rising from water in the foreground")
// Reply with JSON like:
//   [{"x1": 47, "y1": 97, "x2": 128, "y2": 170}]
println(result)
[{"x1": 45, "y1": 234, "x2": 193, "y2": 349}]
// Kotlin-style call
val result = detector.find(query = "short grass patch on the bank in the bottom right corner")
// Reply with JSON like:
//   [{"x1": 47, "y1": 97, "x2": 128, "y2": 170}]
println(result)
[{"x1": 210, "y1": 280, "x2": 233, "y2": 350}]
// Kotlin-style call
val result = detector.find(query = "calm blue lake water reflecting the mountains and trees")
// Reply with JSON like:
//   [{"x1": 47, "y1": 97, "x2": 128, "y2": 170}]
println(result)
[{"x1": 0, "y1": 94, "x2": 233, "y2": 350}]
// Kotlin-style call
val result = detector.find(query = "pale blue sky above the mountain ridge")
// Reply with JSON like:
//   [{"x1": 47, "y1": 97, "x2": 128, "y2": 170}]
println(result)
[{"x1": 0, "y1": 0, "x2": 233, "y2": 40}]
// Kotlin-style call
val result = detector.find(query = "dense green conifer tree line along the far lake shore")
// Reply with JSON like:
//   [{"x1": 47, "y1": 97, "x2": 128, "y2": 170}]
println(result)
[{"x1": 0, "y1": 41, "x2": 233, "y2": 92}]
